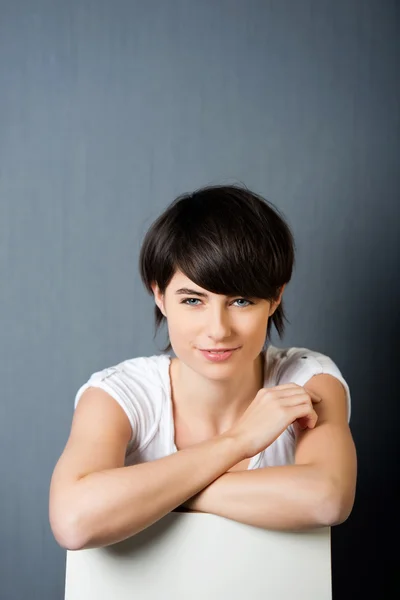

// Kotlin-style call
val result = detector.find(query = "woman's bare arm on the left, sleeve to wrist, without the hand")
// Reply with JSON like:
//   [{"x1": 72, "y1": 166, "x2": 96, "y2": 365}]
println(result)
[{"x1": 49, "y1": 388, "x2": 244, "y2": 550}]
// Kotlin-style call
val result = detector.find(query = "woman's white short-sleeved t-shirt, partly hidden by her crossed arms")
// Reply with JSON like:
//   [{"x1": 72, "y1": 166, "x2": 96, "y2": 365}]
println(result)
[{"x1": 74, "y1": 345, "x2": 351, "y2": 469}]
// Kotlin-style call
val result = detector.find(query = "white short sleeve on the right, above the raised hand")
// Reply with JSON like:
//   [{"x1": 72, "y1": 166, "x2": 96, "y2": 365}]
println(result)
[{"x1": 277, "y1": 348, "x2": 351, "y2": 422}]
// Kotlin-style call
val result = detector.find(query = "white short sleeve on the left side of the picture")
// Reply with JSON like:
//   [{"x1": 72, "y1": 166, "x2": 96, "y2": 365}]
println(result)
[{"x1": 74, "y1": 358, "x2": 160, "y2": 453}]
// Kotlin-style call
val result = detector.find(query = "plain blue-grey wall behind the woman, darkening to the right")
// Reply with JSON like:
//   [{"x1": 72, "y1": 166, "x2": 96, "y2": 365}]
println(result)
[{"x1": 0, "y1": 0, "x2": 400, "y2": 600}]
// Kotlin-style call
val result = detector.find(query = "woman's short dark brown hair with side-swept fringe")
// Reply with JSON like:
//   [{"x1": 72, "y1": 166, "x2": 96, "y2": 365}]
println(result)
[{"x1": 139, "y1": 185, "x2": 295, "y2": 352}]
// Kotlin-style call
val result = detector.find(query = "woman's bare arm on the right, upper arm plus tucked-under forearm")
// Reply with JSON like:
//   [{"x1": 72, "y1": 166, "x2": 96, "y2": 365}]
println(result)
[{"x1": 184, "y1": 374, "x2": 357, "y2": 530}]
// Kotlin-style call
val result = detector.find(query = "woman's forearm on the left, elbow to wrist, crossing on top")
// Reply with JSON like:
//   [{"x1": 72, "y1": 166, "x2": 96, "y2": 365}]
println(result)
[{"x1": 58, "y1": 435, "x2": 243, "y2": 550}]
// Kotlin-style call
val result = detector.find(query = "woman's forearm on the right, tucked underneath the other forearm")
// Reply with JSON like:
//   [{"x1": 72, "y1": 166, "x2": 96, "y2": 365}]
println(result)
[{"x1": 184, "y1": 465, "x2": 335, "y2": 531}]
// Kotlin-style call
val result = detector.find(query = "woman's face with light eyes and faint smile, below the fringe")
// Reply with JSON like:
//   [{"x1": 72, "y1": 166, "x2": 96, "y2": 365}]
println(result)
[{"x1": 153, "y1": 271, "x2": 284, "y2": 379}]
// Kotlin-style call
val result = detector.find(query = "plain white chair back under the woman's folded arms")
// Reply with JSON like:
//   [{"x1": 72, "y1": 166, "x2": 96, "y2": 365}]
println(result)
[{"x1": 65, "y1": 512, "x2": 332, "y2": 600}]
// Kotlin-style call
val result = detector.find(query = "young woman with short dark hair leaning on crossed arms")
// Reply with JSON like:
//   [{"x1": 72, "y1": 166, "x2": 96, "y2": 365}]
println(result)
[{"x1": 49, "y1": 186, "x2": 357, "y2": 550}]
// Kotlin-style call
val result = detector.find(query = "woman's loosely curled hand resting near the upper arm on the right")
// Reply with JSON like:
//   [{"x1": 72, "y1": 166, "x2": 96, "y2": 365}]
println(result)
[{"x1": 226, "y1": 383, "x2": 321, "y2": 458}]
